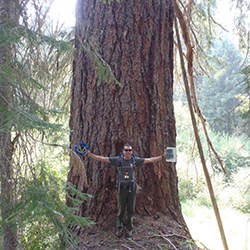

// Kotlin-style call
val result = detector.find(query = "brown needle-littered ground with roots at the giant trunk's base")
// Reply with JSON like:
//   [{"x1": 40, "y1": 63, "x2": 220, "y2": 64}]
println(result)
[{"x1": 80, "y1": 215, "x2": 206, "y2": 250}]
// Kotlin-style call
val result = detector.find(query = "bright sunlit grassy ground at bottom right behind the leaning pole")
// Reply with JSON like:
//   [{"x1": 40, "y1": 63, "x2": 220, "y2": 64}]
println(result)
[{"x1": 182, "y1": 201, "x2": 250, "y2": 250}]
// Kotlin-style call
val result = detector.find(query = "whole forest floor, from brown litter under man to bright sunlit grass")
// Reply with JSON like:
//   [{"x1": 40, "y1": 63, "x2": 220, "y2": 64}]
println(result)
[{"x1": 77, "y1": 206, "x2": 250, "y2": 250}]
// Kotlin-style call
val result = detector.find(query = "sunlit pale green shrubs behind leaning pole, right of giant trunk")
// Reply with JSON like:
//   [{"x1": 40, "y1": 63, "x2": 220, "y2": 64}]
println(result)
[{"x1": 175, "y1": 102, "x2": 250, "y2": 213}]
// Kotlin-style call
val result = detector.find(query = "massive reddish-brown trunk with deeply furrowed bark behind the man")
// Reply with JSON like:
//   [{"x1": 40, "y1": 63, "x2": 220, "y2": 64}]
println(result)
[{"x1": 68, "y1": 0, "x2": 189, "y2": 246}]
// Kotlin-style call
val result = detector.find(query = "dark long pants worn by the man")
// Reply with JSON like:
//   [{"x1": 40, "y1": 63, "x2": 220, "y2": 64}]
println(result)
[{"x1": 117, "y1": 183, "x2": 136, "y2": 231}]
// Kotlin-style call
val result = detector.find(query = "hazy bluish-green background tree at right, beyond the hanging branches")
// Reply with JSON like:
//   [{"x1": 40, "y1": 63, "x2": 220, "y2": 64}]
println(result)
[{"x1": 197, "y1": 41, "x2": 249, "y2": 135}]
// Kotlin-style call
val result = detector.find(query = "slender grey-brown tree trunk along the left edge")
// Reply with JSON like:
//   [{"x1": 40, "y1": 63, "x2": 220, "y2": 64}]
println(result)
[{"x1": 0, "y1": 0, "x2": 19, "y2": 250}]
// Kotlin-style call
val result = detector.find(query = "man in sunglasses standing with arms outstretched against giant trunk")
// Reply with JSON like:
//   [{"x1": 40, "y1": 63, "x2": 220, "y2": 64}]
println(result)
[{"x1": 87, "y1": 144, "x2": 166, "y2": 238}]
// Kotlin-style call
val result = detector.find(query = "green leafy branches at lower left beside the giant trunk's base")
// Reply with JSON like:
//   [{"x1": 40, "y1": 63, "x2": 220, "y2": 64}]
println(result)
[{"x1": 5, "y1": 162, "x2": 93, "y2": 250}]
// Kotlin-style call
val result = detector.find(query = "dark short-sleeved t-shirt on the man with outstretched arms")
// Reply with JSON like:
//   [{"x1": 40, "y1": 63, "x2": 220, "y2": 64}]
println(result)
[{"x1": 109, "y1": 156, "x2": 144, "y2": 181}]
